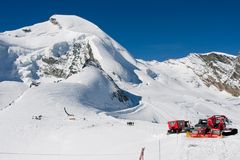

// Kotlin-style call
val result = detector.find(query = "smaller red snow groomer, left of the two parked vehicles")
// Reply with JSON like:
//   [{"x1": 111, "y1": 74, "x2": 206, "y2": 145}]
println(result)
[{"x1": 168, "y1": 120, "x2": 190, "y2": 134}]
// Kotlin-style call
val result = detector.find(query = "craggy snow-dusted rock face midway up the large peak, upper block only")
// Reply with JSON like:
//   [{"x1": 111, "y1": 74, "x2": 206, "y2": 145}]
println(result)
[{"x1": 41, "y1": 41, "x2": 94, "y2": 78}]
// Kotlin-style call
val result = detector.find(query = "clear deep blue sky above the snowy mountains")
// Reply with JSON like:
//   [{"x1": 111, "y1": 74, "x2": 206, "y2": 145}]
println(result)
[{"x1": 0, "y1": 0, "x2": 240, "y2": 60}]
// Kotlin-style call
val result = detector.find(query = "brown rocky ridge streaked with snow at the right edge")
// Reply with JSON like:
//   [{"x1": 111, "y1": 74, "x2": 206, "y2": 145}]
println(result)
[{"x1": 184, "y1": 52, "x2": 240, "y2": 96}]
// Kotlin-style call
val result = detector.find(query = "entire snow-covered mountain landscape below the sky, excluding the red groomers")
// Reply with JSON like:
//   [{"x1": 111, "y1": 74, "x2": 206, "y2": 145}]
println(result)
[{"x1": 0, "y1": 15, "x2": 240, "y2": 160}]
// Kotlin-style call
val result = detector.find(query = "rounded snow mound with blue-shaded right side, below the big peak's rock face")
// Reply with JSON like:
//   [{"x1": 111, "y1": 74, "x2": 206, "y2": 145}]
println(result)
[{"x1": 0, "y1": 67, "x2": 141, "y2": 117}]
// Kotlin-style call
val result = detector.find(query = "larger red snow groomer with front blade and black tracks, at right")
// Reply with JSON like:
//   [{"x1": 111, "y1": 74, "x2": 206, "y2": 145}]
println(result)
[{"x1": 188, "y1": 115, "x2": 238, "y2": 138}]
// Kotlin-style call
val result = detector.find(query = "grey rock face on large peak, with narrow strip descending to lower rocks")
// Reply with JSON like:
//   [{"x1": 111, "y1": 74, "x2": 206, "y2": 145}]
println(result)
[{"x1": 40, "y1": 40, "x2": 134, "y2": 104}]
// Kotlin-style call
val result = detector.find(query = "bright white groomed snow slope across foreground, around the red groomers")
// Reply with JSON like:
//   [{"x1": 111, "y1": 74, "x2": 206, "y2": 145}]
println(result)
[{"x1": 0, "y1": 62, "x2": 240, "y2": 160}]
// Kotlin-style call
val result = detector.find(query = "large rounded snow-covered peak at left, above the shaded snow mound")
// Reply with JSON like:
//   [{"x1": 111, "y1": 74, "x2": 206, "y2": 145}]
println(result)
[{"x1": 0, "y1": 15, "x2": 140, "y2": 83}]
